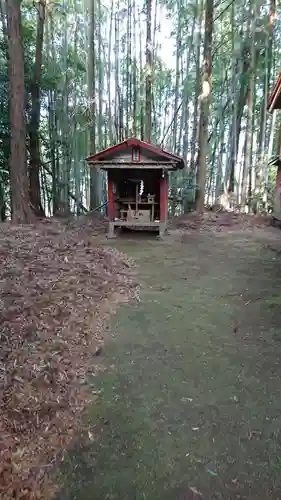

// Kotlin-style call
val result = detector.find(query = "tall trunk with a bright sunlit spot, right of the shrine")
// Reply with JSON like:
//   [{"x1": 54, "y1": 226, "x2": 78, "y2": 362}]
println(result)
[{"x1": 196, "y1": 0, "x2": 214, "y2": 212}]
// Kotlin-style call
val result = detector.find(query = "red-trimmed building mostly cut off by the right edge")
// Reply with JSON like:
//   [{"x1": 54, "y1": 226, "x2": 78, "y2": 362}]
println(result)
[{"x1": 267, "y1": 73, "x2": 281, "y2": 221}]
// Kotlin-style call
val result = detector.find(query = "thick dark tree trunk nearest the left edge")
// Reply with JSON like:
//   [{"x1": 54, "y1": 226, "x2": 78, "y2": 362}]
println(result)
[{"x1": 6, "y1": 0, "x2": 32, "y2": 224}]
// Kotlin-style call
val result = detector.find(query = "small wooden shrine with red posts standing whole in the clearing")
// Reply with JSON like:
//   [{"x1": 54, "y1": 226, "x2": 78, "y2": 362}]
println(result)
[{"x1": 87, "y1": 138, "x2": 184, "y2": 237}]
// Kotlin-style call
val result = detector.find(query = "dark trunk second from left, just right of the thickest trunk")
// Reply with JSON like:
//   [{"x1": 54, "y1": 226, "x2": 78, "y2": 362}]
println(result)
[{"x1": 29, "y1": 0, "x2": 46, "y2": 217}]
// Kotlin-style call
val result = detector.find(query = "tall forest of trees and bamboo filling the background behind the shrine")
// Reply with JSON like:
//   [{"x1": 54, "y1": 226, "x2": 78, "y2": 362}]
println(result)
[{"x1": 0, "y1": 0, "x2": 281, "y2": 222}]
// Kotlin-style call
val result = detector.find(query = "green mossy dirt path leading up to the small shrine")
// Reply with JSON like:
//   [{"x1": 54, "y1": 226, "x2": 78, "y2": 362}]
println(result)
[{"x1": 58, "y1": 230, "x2": 281, "y2": 500}]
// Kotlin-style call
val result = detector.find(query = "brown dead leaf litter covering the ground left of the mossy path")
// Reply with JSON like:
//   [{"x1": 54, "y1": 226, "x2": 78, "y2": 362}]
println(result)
[{"x1": 0, "y1": 217, "x2": 138, "y2": 500}]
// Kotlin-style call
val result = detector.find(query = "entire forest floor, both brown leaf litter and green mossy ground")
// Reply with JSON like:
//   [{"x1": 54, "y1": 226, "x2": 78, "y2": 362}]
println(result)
[{"x1": 0, "y1": 214, "x2": 281, "y2": 500}]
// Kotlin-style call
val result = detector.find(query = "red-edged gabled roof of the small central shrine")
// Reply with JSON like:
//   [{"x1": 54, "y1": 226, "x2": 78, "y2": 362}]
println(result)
[{"x1": 86, "y1": 137, "x2": 185, "y2": 168}]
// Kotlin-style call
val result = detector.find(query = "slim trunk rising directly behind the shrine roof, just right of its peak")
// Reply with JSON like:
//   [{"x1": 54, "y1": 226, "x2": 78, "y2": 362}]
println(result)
[{"x1": 145, "y1": 0, "x2": 152, "y2": 142}]
